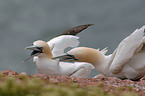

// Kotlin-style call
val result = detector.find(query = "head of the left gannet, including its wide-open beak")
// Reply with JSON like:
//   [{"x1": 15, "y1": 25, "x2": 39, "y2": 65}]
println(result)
[{"x1": 24, "y1": 40, "x2": 52, "y2": 62}]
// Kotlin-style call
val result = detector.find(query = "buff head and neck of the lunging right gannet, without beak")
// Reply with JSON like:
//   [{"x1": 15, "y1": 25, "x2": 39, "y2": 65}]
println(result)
[{"x1": 68, "y1": 47, "x2": 105, "y2": 67}]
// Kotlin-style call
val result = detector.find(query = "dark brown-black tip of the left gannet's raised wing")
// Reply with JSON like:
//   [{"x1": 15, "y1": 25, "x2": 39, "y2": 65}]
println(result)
[{"x1": 58, "y1": 24, "x2": 94, "y2": 36}]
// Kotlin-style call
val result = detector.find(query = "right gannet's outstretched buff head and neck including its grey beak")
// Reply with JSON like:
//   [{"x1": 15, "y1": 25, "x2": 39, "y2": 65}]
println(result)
[{"x1": 53, "y1": 47, "x2": 104, "y2": 65}]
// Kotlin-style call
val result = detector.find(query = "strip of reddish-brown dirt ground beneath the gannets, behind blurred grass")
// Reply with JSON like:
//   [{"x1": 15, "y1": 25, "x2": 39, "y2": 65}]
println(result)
[{"x1": 0, "y1": 69, "x2": 145, "y2": 96}]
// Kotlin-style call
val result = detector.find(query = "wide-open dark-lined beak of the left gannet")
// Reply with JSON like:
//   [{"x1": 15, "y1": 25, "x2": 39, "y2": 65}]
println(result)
[{"x1": 23, "y1": 45, "x2": 43, "y2": 62}]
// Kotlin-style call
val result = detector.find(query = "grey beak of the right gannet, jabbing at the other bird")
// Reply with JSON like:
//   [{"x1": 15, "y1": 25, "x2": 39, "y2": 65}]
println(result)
[{"x1": 52, "y1": 53, "x2": 79, "y2": 62}]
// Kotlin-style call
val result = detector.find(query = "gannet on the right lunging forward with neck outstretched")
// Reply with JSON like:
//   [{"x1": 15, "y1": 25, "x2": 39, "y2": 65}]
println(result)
[{"x1": 54, "y1": 26, "x2": 145, "y2": 81}]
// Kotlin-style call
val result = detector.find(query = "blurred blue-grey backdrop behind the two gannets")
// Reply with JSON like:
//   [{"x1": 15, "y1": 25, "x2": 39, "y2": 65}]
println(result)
[{"x1": 0, "y1": 0, "x2": 145, "y2": 75}]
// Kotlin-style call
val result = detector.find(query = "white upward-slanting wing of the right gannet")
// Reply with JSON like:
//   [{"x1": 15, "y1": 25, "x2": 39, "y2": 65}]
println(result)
[{"x1": 110, "y1": 26, "x2": 145, "y2": 74}]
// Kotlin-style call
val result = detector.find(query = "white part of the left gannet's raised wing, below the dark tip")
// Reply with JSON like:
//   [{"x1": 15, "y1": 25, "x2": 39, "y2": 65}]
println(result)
[{"x1": 47, "y1": 35, "x2": 79, "y2": 57}]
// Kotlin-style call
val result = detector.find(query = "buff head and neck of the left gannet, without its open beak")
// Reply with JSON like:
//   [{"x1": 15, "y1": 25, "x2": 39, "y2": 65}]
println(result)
[{"x1": 33, "y1": 40, "x2": 53, "y2": 58}]
